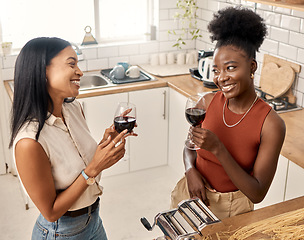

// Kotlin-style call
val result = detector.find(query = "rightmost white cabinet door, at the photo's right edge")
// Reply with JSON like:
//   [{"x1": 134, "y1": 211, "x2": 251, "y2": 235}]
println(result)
[{"x1": 285, "y1": 161, "x2": 304, "y2": 200}]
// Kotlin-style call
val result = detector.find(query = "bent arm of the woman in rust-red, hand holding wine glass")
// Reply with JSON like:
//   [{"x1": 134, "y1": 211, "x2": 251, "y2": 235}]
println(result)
[{"x1": 193, "y1": 110, "x2": 285, "y2": 203}]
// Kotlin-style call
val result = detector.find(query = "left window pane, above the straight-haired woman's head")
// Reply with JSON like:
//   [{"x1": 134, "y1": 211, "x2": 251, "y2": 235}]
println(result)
[{"x1": 0, "y1": 0, "x2": 94, "y2": 48}]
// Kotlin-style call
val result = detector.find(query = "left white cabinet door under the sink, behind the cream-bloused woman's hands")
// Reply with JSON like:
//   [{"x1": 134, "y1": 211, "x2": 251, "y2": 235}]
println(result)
[{"x1": 79, "y1": 93, "x2": 129, "y2": 177}]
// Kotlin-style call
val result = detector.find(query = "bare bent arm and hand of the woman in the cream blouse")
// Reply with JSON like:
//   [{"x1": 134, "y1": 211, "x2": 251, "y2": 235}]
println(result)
[{"x1": 15, "y1": 131, "x2": 126, "y2": 222}]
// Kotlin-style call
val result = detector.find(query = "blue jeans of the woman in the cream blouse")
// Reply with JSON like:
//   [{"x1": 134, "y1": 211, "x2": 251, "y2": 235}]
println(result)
[{"x1": 32, "y1": 207, "x2": 107, "y2": 240}]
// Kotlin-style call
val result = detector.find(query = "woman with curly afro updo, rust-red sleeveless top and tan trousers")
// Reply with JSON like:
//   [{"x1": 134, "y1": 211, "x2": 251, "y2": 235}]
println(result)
[{"x1": 171, "y1": 7, "x2": 285, "y2": 219}]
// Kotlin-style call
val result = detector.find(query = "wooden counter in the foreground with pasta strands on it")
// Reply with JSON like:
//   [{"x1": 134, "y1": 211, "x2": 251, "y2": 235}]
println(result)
[{"x1": 202, "y1": 196, "x2": 304, "y2": 240}]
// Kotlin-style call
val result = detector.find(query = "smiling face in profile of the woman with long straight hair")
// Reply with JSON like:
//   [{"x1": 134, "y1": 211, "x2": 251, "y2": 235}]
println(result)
[{"x1": 46, "y1": 46, "x2": 83, "y2": 101}]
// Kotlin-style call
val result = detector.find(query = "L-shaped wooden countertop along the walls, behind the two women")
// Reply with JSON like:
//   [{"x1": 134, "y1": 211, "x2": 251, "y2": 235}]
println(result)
[{"x1": 4, "y1": 74, "x2": 304, "y2": 168}]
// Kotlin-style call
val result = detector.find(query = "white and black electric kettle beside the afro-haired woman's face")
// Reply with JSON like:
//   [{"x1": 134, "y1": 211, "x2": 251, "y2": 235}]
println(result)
[{"x1": 198, "y1": 50, "x2": 216, "y2": 88}]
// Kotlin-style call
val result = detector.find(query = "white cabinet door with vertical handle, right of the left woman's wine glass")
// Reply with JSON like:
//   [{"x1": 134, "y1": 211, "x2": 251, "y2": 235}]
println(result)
[{"x1": 129, "y1": 87, "x2": 168, "y2": 171}]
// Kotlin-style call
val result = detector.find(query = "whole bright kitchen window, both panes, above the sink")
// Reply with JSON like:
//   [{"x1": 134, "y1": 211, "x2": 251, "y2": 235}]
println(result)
[{"x1": 0, "y1": 0, "x2": 156, "y2": 48}]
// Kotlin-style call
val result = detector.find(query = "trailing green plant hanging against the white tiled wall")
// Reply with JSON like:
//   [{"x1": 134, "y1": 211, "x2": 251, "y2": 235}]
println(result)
[{"x1": 168, "y1": 0, "x2": 202, "y2": 49}]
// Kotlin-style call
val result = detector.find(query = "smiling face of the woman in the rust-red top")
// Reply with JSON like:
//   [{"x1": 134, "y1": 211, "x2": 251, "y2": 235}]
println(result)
[{"x1": 213, "y1": 46, "x2": 257, "y2": 99}]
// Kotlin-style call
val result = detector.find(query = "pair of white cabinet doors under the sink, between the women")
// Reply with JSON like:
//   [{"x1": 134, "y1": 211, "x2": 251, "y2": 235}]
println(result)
[{"x1": 79, "y1": 87, "x2": 168, "y2": 176}]
